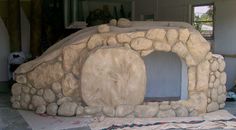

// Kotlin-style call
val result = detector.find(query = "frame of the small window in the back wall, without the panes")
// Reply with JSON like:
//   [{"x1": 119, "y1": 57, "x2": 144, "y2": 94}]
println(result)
[{"x1": 191, "y1": 3, "x2": 215, "y2": 40}]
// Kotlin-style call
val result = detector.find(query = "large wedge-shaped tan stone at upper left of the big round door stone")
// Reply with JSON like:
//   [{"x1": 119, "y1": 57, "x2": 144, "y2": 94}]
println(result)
[{"x1": 62, "y1": 43, "x2": 86, "y2": 71}]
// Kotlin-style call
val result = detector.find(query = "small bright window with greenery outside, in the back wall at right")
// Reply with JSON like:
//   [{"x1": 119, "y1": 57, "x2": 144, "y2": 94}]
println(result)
[{"x1": 192, "y1": 4, "x2": 214, "y2": 39}]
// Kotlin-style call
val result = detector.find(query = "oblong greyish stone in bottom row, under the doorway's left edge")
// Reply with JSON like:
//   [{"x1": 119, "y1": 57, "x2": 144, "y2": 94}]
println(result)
[{"x1": 134, "y1": 105, "x2": 158, "y2": 118}]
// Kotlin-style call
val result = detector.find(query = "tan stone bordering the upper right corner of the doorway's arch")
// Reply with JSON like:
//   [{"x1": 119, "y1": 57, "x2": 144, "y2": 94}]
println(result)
[{"x1": 172, "y1": 42, "x2": 188, "y2": 58}]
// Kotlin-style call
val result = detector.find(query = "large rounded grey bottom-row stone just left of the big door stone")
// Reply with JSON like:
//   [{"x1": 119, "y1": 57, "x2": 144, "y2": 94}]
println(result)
[{"x1": 58, "y1": 102, "x2": 77, "y2": 116}]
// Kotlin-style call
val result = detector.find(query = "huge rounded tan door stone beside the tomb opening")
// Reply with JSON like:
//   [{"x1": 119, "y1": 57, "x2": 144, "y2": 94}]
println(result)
[{"x1": 81, "y1": 48, "x2": 146, "y2": 106}]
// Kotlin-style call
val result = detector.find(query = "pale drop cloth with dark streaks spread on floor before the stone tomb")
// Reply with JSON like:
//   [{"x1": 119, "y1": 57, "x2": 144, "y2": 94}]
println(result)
[{"x1": 19, "y1": 110, "x2": 236, "y2": 130}]
